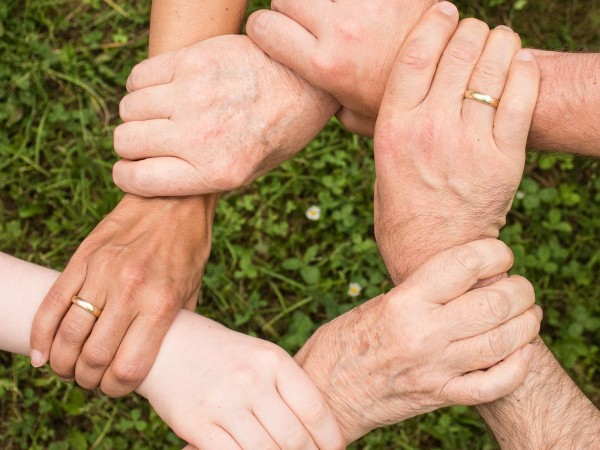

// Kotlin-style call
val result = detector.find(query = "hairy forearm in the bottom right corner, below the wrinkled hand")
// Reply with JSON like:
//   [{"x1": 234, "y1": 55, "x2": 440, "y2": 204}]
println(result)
[{"x1": 477, "y1": 338, "x2": 600, "y2": 449}]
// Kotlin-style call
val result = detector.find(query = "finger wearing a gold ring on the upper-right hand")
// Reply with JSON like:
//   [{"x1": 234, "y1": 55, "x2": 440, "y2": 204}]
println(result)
[{"x1": 462, "y1": 26, "x2": 521, "y2": 130}]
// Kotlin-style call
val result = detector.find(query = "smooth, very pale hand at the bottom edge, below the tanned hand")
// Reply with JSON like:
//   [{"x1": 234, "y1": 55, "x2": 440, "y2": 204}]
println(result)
[{"x1": 138, "y1": 312, "x2": 344, "y2": 450}]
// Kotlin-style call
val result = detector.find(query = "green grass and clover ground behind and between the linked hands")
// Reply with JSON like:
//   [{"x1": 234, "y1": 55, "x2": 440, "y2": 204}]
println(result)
[{"x1": 0, "y1": 0, "x2": 600, "y2": 449}]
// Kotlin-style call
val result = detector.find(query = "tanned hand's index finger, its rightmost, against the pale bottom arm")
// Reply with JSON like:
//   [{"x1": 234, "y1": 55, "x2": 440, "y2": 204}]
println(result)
[{"x1": 100, "y1": 306, "x2": 179, "y2": 397}]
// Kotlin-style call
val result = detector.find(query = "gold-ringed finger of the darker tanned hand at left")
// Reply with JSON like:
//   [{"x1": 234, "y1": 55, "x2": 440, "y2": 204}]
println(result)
[{"x1": 50, "y1": 284, "x2": 106, "y2": 379}]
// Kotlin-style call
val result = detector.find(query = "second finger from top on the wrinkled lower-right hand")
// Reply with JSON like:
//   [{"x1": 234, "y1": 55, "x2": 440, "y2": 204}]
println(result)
[{"x1": 434, "y1": 275, "x2": 535, "y2": 341}]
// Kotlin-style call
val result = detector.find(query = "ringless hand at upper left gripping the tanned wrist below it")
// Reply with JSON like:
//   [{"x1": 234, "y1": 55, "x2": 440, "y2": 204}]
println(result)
[{"x1": 113, "y1": 36, "x2": 337, "y2": 196}]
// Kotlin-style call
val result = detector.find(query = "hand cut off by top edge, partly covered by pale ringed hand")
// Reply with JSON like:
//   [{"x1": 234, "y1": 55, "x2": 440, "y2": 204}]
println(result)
[{"x1": 246, "y1": 0, "x2": 438, "y2": 136}]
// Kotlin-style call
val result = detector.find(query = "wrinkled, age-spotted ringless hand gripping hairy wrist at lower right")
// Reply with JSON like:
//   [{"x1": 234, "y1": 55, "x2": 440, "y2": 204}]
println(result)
[{"x1": 296, "y1": 239, "x2": 542, "y2": 442}]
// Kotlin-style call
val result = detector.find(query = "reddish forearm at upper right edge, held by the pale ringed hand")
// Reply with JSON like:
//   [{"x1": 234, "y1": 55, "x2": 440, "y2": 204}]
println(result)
[{"x1": 528, "y1": 50, "x2": 600, "y2": 157}]
